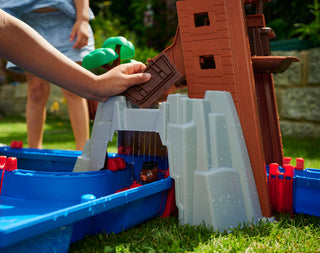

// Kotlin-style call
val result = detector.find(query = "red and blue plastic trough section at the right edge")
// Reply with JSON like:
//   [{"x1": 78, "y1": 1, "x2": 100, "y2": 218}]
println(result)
[{"x1": 267, "y1": 158, "x2": 320, "y2": 217}]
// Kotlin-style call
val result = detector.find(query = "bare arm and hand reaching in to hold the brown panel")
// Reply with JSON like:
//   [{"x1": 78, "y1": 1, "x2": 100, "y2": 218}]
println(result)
[{"x1": 0, "y1": 10, "x2": 151, "y2": 101}]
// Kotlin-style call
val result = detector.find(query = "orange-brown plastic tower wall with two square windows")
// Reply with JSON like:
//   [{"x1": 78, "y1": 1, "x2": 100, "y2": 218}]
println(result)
[{"x1": 177, "y1": 0, "x2": 271, "y2": 217}]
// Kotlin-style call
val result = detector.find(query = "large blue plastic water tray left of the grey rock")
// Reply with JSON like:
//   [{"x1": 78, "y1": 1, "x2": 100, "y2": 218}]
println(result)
[{"x1": 0, "y1": 147, "x2": 173, "y2": 252}]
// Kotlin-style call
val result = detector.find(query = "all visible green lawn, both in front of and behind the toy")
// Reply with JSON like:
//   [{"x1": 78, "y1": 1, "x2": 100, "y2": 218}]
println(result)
[{"x1": 0, "y1": 117, "x2": 320, "y2": 252}]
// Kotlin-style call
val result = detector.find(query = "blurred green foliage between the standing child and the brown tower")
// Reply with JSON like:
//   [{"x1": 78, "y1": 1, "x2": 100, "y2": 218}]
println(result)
[{"x1": 90, "y1": 0, "x2": 177, "y2": 62}]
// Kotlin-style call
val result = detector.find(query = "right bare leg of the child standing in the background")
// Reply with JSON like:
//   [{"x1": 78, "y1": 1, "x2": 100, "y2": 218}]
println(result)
[{"x1": 61, "y1": 89, "x2": 89, "y2": 150}]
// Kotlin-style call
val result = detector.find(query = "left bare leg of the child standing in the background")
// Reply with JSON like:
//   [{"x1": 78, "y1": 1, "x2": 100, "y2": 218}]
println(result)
[{"x1": 26, "y1": 73, "x2": 50, "y2": 148}]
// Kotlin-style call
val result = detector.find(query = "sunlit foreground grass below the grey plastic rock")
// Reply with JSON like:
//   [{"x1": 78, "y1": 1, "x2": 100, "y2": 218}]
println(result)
[{"x1": 69, "y1": 215, "x2": 320, "y2": 253}]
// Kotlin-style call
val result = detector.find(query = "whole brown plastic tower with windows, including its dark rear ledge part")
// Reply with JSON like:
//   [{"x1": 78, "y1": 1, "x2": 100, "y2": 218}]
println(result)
[{"x1": 159, "y1": 0, "x2": 298, "y2": 217}]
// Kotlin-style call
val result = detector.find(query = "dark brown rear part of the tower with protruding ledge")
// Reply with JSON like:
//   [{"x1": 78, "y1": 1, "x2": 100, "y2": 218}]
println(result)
[{"x1": 245, "y1": 0, "x2": 298, "y2": 164}]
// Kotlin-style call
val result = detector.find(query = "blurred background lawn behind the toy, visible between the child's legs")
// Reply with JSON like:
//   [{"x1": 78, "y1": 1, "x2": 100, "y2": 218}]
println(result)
[{"x1": 0, "y1": 117, "x2": 320, "y2": 169}]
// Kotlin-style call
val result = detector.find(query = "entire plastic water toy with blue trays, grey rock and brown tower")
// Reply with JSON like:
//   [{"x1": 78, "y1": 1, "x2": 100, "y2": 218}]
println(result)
[{"x1": 0, "y1": 0, "x2": 320, "y2": 252}]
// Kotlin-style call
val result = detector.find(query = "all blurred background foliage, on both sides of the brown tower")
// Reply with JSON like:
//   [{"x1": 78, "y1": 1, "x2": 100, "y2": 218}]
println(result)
[{"x1": 0, "y1": 0, "x2": 320, "y2": 83}]
